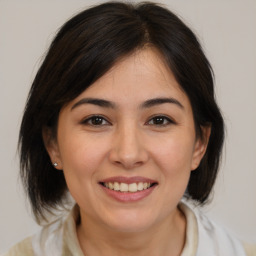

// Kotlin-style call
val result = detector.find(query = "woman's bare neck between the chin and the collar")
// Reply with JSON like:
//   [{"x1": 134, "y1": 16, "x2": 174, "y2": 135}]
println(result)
[{"x1": 77, "y1": 208, "x2": 186, "y2": 256}]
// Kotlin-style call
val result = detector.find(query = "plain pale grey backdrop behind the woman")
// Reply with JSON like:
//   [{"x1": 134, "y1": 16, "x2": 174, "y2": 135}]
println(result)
[{"x1": 0, "y1": 0, "x2": 256, "y2": 253}]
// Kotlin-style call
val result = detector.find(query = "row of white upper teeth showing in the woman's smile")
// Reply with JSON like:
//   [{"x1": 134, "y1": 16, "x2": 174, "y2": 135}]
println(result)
[{"x1": 103, "y1": 182, "x2": 151, "y2": 192}]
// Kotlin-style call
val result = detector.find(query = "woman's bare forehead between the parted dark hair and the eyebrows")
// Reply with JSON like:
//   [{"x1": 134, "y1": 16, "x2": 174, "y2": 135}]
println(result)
[{"x1": 68, "y1": 47, "x2": 188, "y2": 108}]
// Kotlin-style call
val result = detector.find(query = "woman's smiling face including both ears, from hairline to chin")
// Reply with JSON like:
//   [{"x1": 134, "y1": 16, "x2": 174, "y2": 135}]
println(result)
[{"x1": 46, "y1": 49, "x2": 209, "y2": 232}]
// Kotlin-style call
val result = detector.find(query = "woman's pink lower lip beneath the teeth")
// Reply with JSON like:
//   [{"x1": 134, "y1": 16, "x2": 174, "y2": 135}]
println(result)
[{"x1": 101, "y1": 185, "x2": 156, "y2": 202}]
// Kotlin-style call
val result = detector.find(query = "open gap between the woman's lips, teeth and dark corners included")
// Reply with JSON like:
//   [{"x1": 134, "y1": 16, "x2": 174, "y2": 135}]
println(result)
[{"x1": 100, "y1": 181, "x2": 157, "y2": 193}]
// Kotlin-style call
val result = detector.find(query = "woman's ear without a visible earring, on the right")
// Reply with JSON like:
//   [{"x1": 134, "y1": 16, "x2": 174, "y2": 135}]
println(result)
[{"x1": 191, "y1": 125, "x2": 211, "y2": 171}]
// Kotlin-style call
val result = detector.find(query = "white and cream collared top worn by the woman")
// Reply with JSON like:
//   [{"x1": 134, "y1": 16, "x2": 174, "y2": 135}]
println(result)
[{"x1": 3, "y1": 202, "x2": 256, "y2": 256}]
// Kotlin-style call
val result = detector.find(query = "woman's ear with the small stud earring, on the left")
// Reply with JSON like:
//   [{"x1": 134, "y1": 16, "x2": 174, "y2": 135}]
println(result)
[{"x1": 42, "y1": 127, "x2": 62, "y2": 170}]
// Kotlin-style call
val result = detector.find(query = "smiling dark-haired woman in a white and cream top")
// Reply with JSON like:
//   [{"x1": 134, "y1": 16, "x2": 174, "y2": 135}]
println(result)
[{"x1": 3, "y1": 2, "x2": 255, "y2": 256}]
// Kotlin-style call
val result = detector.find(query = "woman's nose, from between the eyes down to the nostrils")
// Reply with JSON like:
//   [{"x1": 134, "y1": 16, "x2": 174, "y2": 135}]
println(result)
[{"x1": 109, "y1": 122, "x2": 149, "y2": 170}]
